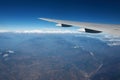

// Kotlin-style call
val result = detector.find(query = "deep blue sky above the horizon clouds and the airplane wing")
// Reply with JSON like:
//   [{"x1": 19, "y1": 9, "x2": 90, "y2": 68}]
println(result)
[{"x1": 0, "y1": 0, "x2": 120, "y2": 29}]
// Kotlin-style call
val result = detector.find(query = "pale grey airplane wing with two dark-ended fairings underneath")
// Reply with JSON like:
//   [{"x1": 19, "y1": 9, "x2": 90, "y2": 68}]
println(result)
[{"x1": 39, "y1": 18, "x2": 120, "y2": 36}]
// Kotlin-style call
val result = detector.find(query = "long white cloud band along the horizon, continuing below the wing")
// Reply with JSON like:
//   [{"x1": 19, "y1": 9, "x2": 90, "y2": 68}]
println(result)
[{"x1": 0, "y1": 28, "x2": 120, "y2": 46}]
